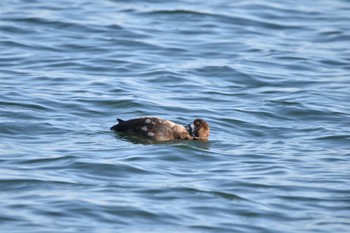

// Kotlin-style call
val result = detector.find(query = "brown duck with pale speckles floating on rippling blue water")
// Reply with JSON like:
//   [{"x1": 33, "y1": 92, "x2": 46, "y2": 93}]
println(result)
[{"x1": 110, "y1": 117, "x2": 210, "y2": 141}]
